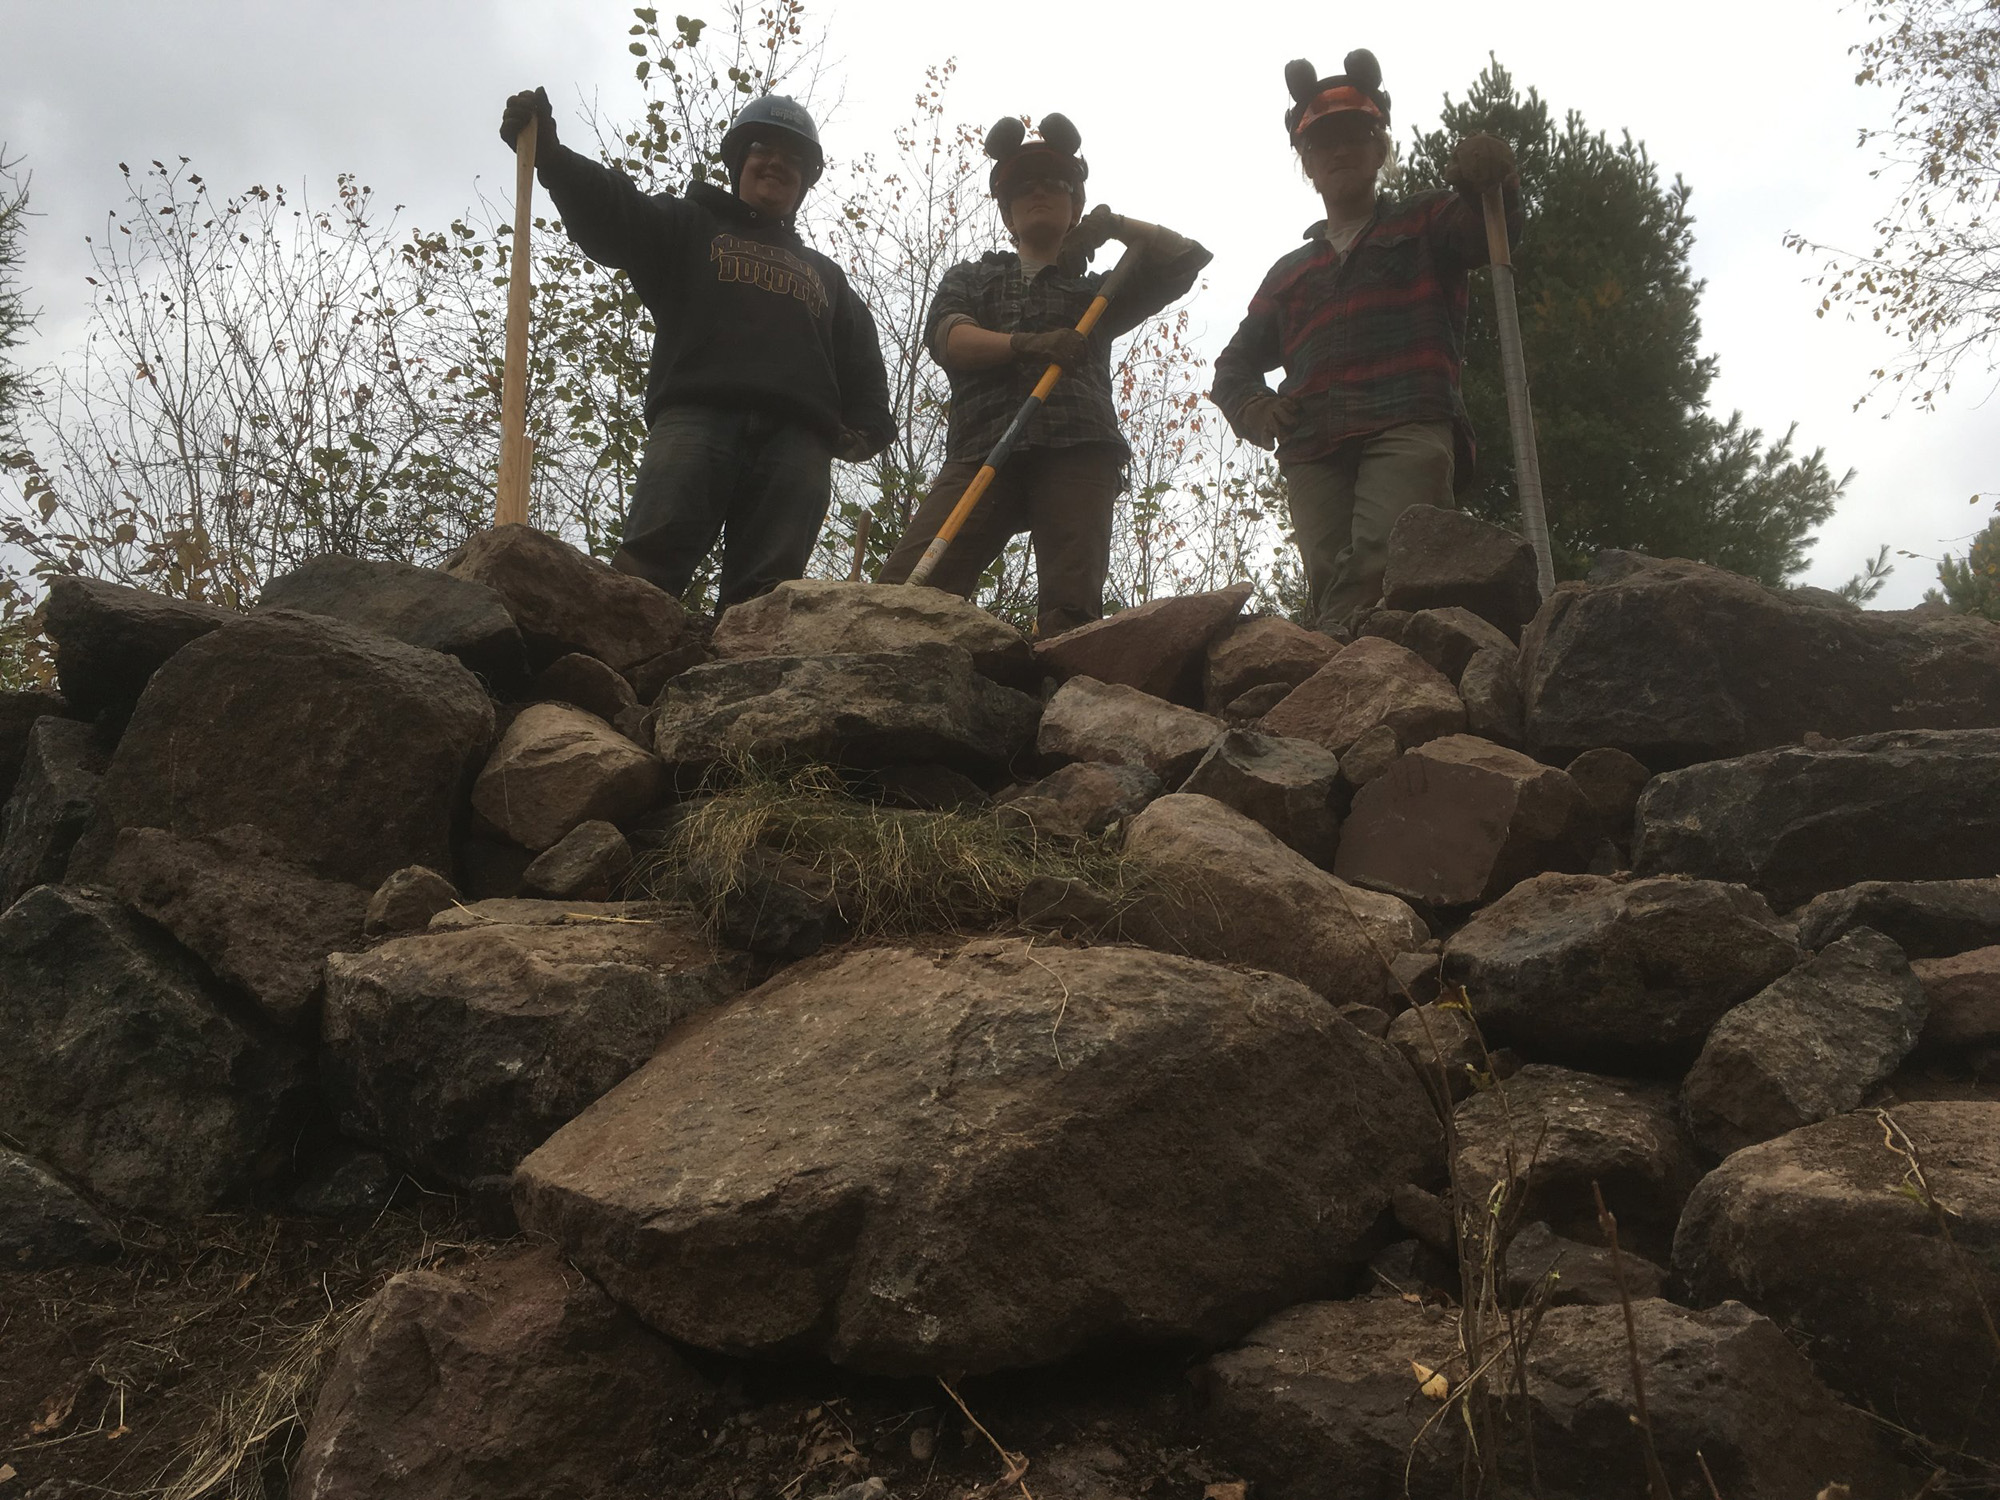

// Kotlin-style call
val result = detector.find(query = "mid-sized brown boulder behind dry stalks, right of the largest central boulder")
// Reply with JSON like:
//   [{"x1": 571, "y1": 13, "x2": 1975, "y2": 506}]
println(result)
[{"x1": 1452, "y1": 1064, "x2": 1702, "y2": 1260}]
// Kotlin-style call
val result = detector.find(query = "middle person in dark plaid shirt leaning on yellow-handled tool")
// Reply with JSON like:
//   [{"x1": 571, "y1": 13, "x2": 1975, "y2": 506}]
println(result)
[{"x1": 882, "y1": 114, "x2": 1210, "y2": 636}]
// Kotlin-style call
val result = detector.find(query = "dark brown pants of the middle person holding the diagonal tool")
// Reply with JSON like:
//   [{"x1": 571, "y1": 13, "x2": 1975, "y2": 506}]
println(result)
[{"x1": 882, "y1": 442, "x2": 1124, "y2": 636}]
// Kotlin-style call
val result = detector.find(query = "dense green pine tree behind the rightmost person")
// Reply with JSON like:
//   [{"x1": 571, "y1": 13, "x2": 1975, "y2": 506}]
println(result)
[{"x1": 1404, "y1": 62, "x2": 1848, "y2": 584}]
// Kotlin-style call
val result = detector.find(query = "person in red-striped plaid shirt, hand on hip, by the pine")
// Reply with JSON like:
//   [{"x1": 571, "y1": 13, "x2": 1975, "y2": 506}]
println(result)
[{"x1": 1210, "y1": 48, "x2": 1520, "y2": 638}]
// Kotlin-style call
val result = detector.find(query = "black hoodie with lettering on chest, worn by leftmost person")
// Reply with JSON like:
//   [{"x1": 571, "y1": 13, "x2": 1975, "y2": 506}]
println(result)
[{"x1": 536, "y1": 146, "x2": 896, "y2": 454}]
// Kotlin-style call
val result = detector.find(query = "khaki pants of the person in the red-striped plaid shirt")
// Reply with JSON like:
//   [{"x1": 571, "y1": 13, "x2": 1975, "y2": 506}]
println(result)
[{"x1": 1284, "y1": 422, "x2": 1456, "y2": 630}]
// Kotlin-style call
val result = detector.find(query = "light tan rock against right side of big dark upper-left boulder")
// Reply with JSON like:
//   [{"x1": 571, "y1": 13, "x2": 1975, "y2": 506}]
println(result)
[{"x1": 472, "y1": 704, "x2": 666, "y2": 850}]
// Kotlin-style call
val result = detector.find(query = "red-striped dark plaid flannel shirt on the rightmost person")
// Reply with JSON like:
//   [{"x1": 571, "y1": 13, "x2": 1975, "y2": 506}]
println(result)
[{"x1": 1210, "y1": 188, "x2": 1520, "y2": 472}]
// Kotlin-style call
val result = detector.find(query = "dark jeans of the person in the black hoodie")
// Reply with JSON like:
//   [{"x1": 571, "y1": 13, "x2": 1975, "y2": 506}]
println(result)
[{"x1": 612, "y1": 406, "x2": 832, "y2": 612}]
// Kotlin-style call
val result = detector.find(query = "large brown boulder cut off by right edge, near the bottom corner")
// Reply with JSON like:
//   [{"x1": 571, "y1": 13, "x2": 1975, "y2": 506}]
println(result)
[{"x1": 1674, "y1": 1102, "x2": 2000, "y2": 1456}]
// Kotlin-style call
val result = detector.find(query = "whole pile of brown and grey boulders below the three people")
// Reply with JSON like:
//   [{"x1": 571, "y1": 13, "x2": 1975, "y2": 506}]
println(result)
[{"x1": 0, "y1": 512, "x2": 2000, "y2": 1500}]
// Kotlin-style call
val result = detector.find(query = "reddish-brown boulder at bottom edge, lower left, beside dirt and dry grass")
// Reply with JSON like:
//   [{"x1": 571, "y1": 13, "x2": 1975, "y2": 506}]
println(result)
[{"x1": 292, "y1": 1246, "x2": 710, "y2": 1500}]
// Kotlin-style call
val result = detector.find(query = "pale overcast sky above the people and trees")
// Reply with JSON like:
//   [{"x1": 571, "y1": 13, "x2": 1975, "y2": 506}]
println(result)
[{"x1": 0, "y1": 0, "x2": 2000, "y2": 606}]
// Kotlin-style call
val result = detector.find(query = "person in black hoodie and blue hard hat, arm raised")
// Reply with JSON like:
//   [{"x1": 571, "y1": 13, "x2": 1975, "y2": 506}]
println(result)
[{"x1": 500, "y1": 88, "x2": 896, "y2": 612}]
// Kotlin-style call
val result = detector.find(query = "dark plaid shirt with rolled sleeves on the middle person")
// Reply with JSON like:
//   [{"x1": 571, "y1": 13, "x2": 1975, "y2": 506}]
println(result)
[{"x1": 924, "y1": 240, "x2": 1210, "y2": 462}]
